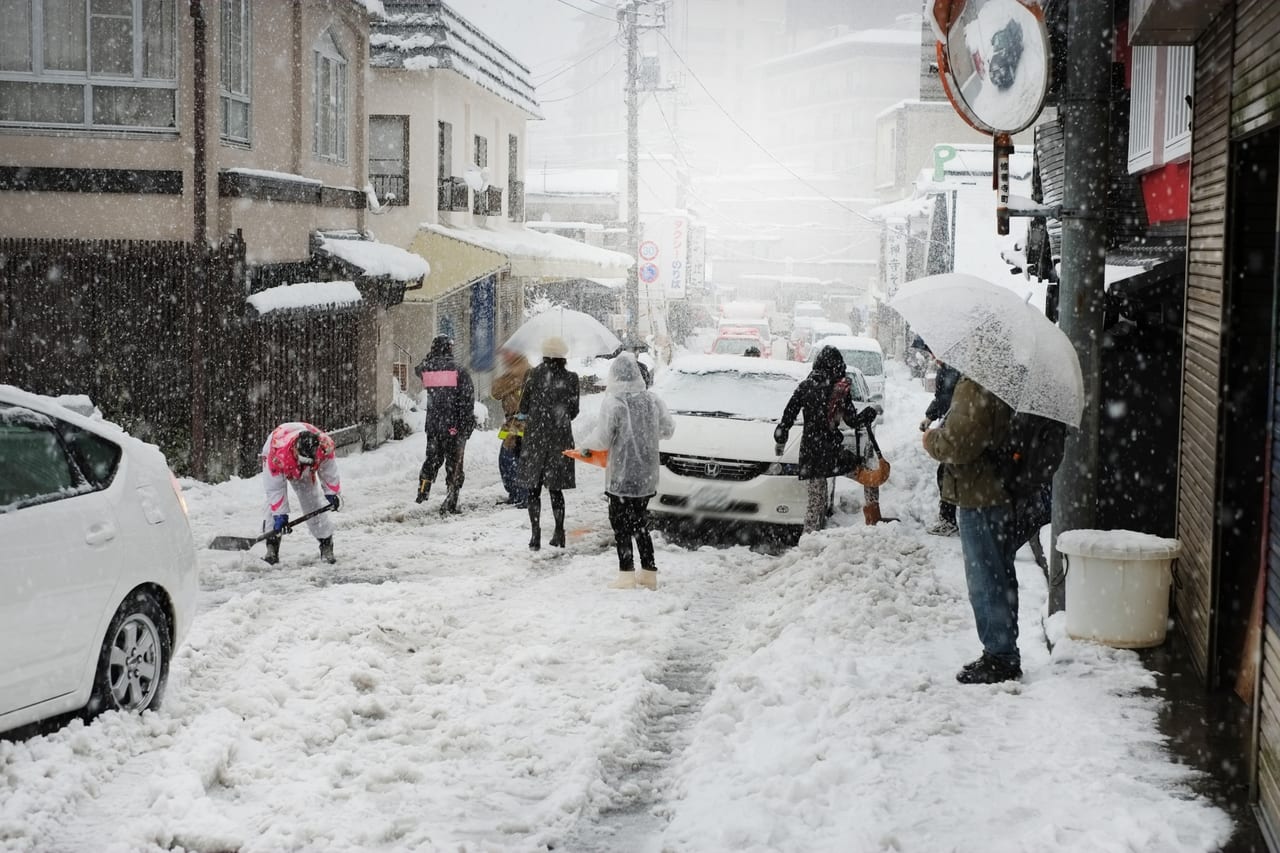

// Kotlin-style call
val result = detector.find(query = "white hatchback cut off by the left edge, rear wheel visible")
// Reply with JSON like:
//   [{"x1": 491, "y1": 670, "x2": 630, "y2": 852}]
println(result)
[{"x1": 0, "y1": 386, "x2": 198, "y2": 731}]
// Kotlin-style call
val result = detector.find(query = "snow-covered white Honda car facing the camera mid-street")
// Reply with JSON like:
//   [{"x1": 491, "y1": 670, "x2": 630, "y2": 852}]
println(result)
[{"x1": 649, "y1": 355, "x2": 809, "y2": 539}]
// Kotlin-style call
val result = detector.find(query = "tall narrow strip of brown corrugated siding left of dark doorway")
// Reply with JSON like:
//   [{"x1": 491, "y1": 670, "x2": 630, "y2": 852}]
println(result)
[{"x1": 1174, "y1": 6, "x2": 1231, "y2": 676}]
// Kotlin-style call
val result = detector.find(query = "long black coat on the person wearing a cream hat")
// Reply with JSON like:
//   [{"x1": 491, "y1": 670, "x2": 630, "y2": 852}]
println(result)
[{"x1": 517, "y1": 359, "x2": 579, "y2": 491}]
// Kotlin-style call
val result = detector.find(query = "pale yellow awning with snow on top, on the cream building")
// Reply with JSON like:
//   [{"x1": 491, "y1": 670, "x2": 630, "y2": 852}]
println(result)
[{"x1": 407, "y1": 223, "x2": 632, "y2": 300}]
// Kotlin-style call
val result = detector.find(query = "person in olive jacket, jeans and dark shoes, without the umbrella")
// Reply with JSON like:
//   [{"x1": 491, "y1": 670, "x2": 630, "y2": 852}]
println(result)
[{"x1": 922, "y1": 377, "x2": 1023, "y2": 684}]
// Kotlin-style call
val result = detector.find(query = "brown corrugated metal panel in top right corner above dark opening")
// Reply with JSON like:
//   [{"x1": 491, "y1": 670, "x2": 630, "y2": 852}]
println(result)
[{"x1": 1228, "y1": 0, "x2": 1280, "y2": 136}]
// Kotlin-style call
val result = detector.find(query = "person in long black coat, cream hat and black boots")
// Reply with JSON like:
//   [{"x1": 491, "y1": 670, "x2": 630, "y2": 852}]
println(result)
[{"x1": 517, "y1": 338, "x2": 579, "y2": 551}]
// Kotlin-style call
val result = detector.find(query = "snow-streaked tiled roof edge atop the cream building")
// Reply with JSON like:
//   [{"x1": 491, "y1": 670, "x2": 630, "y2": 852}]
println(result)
[{"x1": 369, "y1": 0, "x2": 541, "y2": 118}]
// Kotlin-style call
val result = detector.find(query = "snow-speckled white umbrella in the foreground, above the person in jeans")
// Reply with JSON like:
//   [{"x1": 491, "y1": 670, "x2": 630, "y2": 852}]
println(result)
[{"x1": 888, "y1": 273, "x2": 1084, "y2": 427}]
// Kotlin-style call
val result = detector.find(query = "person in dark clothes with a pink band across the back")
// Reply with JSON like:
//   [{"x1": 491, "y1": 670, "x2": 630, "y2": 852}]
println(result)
[{"x1": 415, "y1": 334, "x2": 476, "y2": 515}]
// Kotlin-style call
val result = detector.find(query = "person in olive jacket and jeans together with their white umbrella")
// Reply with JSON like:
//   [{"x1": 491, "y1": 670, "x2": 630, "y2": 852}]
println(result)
[{"x1": 890, "y1": 273, "x2": 1084, "y2": 684}]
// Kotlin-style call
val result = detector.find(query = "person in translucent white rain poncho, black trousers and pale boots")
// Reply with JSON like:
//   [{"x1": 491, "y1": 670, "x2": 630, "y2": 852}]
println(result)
[{"x1": 579, "y1": 352, "x2": 676, "y2": 589}]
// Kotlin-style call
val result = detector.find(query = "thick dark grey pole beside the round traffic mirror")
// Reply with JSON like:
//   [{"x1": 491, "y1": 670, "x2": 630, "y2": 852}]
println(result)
[{"x1": 1048, "y1": 0, "x2": 1115, "y2": 613}]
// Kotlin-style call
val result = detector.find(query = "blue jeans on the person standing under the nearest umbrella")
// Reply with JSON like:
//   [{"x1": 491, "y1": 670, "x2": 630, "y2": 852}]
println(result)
[{"x1": 956, "y1": 506, "x2": 1021, "y2": 666}]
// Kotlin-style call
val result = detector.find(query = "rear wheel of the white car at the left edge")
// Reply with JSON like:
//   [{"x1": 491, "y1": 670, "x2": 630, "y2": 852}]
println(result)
[{"x1": 86, "y1": 592, "x2": 173, "y2": 717}]
